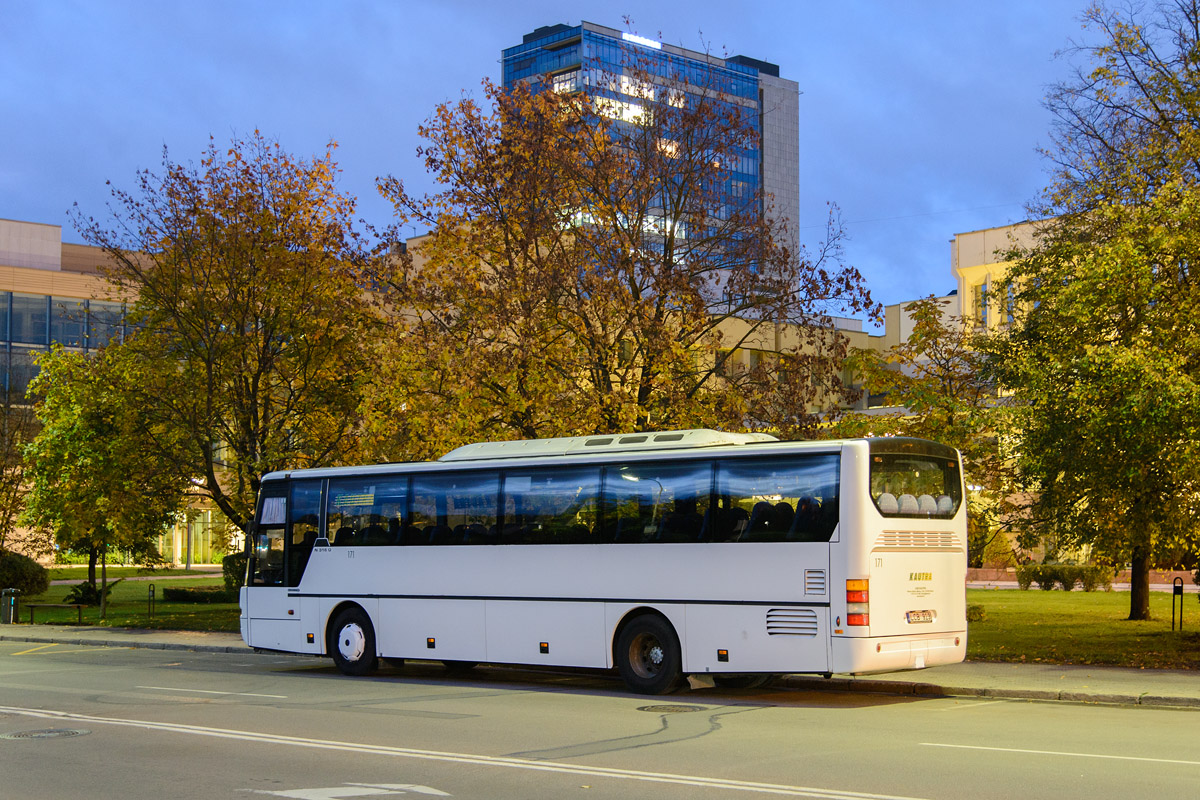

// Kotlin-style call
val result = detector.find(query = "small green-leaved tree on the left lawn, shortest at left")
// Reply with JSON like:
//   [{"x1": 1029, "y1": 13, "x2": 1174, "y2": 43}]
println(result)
[{"x1": 24, "y1": 345, "x2": 188, "y2": 615}]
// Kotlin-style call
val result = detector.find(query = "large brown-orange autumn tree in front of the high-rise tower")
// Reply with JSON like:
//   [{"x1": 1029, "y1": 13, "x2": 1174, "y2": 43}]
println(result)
[{"x1": 364, "y1": 65, "x2": 870, "y2": 456}]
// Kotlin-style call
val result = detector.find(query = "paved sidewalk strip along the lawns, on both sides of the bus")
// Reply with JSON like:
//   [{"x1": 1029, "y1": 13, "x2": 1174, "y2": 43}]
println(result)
[{"x1": 0, "y1": 625, "x2": 1200, "y2": 709}]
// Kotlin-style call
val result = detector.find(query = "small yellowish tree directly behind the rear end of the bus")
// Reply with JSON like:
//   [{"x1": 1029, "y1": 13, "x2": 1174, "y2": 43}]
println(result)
[{"x1": 824, "y1": 297, "x2": 1019, "y2": 566}]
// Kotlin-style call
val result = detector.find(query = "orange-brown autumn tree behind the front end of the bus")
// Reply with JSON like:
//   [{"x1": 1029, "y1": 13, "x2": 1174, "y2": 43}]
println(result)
[{"x1": 77, "y1": 131, "x2": 376, "y2": 528}]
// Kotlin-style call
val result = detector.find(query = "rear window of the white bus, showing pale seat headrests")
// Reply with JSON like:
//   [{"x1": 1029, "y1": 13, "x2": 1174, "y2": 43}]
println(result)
[{"x1": 871, "y1": 453, "x2": 962, "y2": 519}]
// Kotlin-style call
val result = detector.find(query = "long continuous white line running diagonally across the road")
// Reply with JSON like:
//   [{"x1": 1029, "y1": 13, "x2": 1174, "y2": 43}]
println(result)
[{"x1": 0, "y1": 705, "x2": 919, "y2": 800}]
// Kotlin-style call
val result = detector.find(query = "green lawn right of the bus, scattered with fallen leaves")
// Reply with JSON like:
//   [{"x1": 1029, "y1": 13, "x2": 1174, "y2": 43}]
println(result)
[{"x1": 967, "y1": 589, "x2": 1200, "y2": 669}]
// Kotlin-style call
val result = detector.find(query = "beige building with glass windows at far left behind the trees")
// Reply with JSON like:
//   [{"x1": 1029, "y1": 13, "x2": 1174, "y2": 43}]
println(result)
[{"x1": 0, "y1": 219, "x2": 222, "y2": 564}]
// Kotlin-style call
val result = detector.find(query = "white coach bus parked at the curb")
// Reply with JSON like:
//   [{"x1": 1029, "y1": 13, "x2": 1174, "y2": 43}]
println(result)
[{"x1": 241, "y1": 429, "x2": 967, "y2": 693}]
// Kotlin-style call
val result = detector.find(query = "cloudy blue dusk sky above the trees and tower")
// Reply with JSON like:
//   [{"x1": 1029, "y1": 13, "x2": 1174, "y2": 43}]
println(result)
[{"x1": 0, "y1": 0, "x2": 1086, "y2": 326}]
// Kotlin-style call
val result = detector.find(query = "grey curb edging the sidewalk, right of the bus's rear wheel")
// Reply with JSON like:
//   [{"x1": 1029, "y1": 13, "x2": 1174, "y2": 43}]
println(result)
[{"x1": 779, "y1": 675, "x2": 1200, "y2": 709}]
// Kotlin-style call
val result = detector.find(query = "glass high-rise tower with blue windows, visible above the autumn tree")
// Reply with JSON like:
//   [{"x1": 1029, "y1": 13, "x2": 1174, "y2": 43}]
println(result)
[{"x1": 502, "y1": 22, "x2": 800, "y2": 239}]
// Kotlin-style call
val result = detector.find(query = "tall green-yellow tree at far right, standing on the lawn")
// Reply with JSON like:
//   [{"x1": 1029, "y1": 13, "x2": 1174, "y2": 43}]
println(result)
[{"x1": 988, "y1": 0, "x2": 1200, "y2": 619}]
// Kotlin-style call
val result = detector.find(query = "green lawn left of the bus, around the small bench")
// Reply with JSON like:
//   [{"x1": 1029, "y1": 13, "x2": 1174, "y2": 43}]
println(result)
[{"x1": 20, "y1": 575, "x2": 238, "y2": 632}]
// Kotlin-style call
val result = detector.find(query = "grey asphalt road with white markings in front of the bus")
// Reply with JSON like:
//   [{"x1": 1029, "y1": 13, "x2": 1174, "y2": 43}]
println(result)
[{"x1": 0, "y1": 642, "x2": 1200, "y2": 800}]
